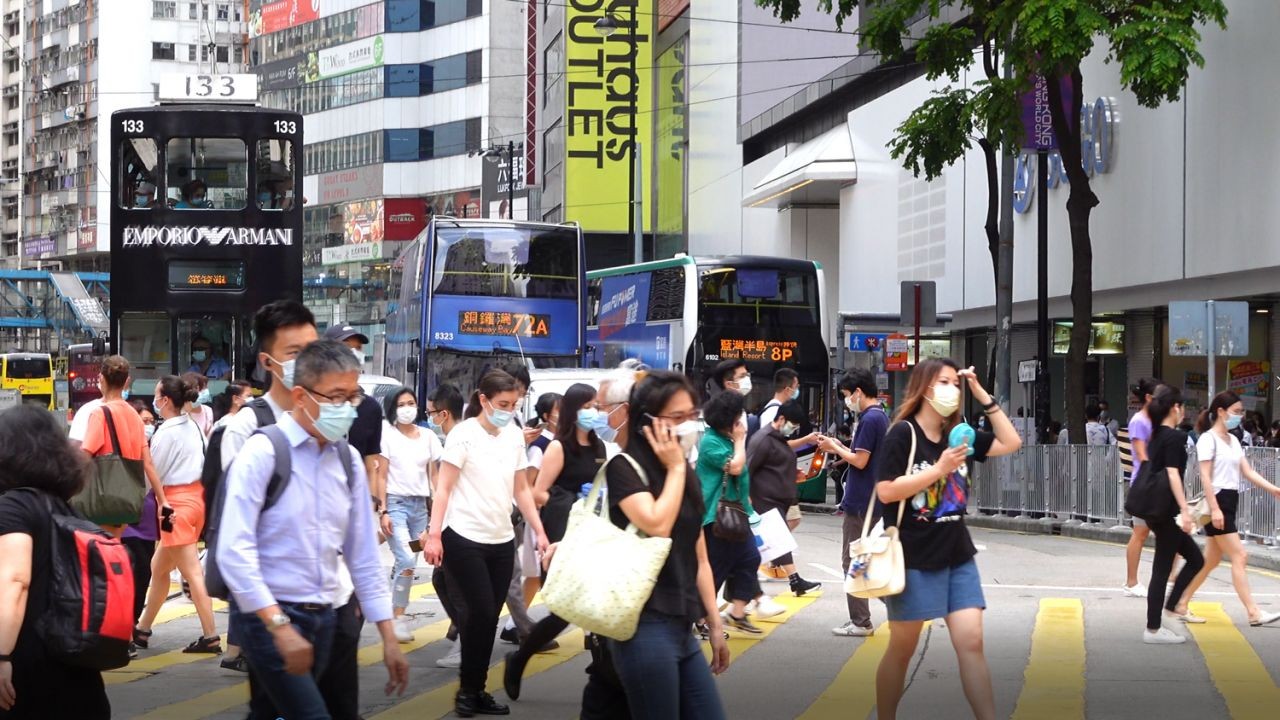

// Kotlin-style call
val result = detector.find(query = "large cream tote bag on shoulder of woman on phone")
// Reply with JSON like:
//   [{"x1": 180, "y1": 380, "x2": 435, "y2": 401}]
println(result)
[{"x1": 543, "y1": 452, "x2": 671, "y2": 641}]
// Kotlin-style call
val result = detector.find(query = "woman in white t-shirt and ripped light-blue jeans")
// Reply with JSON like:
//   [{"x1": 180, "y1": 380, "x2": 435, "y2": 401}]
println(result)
[{"x1": 381, "y1": 387, "x2": 444, "y2": 643}]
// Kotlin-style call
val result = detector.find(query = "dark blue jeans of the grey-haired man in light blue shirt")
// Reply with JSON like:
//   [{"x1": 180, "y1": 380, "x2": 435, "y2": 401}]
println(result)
[{"x1": 233, "y1": 602, "x2": 335, "y2": 720}]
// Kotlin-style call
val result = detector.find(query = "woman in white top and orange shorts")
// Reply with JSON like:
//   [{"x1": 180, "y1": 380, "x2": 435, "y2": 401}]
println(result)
[{"x1": 133, "y1": 375, "x2": 223, "y2": 655}]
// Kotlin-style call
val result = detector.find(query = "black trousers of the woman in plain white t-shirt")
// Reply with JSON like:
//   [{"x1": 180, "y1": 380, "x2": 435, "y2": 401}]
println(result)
[{"x1": 440, "y1": 528, "x2": 516, "y2": 692}]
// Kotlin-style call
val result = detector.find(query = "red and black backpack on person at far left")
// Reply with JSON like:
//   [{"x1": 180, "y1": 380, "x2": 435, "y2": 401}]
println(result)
[{"x1": 10, "y1": 488, "x2": 133, "y2": 670}]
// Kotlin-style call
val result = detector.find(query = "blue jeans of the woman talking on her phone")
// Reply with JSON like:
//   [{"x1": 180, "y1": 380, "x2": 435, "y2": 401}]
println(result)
[{"x1": 608, "y1": 610, "x2": 724, "y2": 720}]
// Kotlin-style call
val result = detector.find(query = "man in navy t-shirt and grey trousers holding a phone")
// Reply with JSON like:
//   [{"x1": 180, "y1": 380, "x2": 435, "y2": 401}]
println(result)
[{"x1": 819, "y1": 368, "x2": 890, "y2": 638}]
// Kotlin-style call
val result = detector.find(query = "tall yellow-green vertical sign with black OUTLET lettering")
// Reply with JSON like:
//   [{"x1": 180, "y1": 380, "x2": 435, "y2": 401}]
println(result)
[{"x1": 564, "y1": 0, "x2": 654, "y2": 232}]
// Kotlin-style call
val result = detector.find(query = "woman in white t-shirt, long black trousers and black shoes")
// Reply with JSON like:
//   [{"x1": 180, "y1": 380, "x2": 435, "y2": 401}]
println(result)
[{"x1": 422, "y1": 370, "x2": 547, "y2": 717}]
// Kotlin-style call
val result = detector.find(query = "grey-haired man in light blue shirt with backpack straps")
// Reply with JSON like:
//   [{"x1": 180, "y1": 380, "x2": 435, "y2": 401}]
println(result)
[{"x1": 216, "y1": 341, "x2": 408, "y2": 720}]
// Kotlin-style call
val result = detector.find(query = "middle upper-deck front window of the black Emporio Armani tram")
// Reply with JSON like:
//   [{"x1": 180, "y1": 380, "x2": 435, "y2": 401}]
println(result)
[{"x1": 165, "y1": 137, "x2": 248, "y2": 210}]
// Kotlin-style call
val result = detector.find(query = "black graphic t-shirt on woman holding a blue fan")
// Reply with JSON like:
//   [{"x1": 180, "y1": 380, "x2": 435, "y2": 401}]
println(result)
[{"x1": 878, "y1": 419, "x2": 996, "y2": 570}]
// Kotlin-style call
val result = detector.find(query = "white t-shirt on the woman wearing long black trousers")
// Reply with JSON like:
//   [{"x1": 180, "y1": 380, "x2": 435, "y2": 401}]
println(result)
[{"x1": 443, "y1": 418, "x2": 529, "y2": 544}]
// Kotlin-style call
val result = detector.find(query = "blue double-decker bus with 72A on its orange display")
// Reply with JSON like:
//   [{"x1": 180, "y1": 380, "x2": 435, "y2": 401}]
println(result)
[{"x1": 387, "y1": 217, "x2": 586, "y2": 397}]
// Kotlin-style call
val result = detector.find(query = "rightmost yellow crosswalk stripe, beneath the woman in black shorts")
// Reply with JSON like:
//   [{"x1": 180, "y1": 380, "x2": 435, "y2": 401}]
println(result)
[{"x1": 1187, "y1": 602, "x2": 1280, "y2": 720}]
